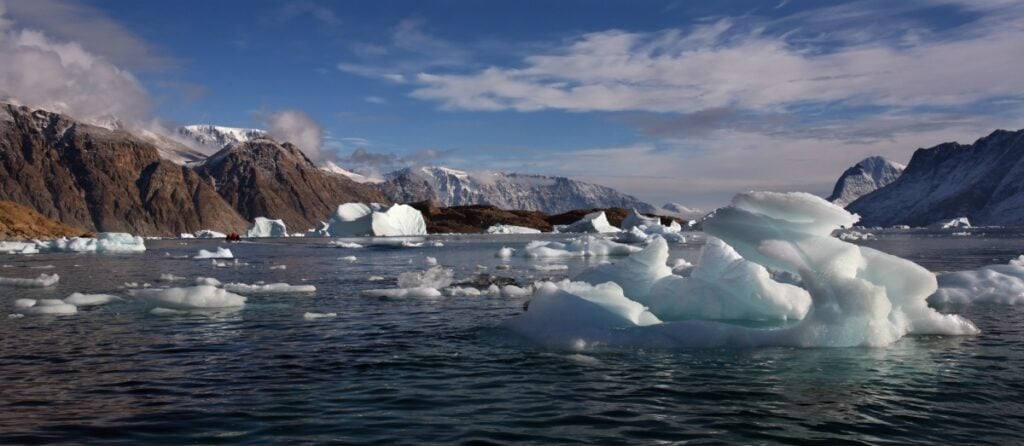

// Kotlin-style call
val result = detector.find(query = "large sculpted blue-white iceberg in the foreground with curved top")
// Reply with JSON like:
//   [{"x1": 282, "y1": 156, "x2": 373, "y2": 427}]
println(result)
[{"x1": 504, "y1": 192, "x2": 978, "y2": 350}]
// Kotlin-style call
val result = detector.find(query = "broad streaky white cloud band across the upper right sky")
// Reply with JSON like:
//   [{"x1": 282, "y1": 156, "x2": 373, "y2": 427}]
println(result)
[{"x1": 412, "y1": 14, "x2": 1024, "y2": 113}]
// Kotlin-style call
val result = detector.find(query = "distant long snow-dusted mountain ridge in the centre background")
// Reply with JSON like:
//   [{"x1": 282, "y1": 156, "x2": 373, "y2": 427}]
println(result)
[{"x1": 378, "y1": 167, "x2": 655, "y2": 214}]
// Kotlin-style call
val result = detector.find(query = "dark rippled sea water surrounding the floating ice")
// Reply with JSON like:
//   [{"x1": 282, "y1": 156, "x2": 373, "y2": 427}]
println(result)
[{"x1": 0, "y1": 233, "x2": 1024, "y2": 445}]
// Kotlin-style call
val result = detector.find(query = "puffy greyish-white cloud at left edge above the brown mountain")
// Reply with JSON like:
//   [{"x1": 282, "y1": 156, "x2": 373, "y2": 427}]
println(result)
[{"x1": 0, "y1": 4, "x2": 151, "y2": 122}]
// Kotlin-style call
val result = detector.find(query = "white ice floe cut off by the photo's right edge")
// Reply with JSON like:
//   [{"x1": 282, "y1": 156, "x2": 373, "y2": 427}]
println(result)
[{"x1": 928, "y1": 256, "x2": 1024, "y2": 305}]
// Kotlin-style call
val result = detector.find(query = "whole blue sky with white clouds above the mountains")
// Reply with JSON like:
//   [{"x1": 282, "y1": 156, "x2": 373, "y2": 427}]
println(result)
[{"x1": 0, "y1": 0, "x2": 1024, "y2": 209}]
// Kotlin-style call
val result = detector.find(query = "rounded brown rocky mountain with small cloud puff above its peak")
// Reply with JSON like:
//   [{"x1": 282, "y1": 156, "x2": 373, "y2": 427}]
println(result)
[{"x1": 196, "y1": 138, "x2": 388, "y2": 231}]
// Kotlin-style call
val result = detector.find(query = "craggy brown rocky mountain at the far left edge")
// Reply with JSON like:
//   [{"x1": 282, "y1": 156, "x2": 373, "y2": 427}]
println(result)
[{"x1": 0, "y1": 104, "x2": 247, "y2": 235}]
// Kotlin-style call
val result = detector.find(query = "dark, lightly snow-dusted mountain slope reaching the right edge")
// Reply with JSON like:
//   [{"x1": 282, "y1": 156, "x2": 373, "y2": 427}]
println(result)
[{"x1": 847, "y1": 130, "x2": 1024, "y2": 226}]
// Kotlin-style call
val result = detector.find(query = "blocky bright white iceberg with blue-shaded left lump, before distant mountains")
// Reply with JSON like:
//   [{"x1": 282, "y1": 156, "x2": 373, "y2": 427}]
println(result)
[{"x1": 327, "y1": 203, "x2": 427, "y2": 237}]
